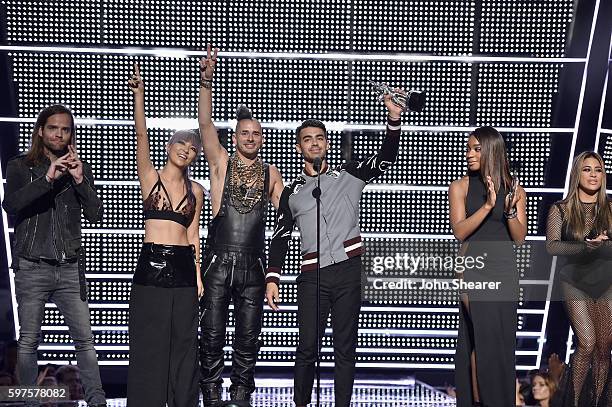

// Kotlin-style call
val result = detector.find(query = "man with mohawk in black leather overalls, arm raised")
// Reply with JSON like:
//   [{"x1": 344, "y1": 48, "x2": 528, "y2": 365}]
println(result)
[{"x1": 198, "y1": 46, "x2": 283, "y2": 406}]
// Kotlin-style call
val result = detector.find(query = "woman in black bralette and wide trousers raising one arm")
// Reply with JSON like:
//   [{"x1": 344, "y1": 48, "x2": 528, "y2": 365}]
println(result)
[{"x1": 127, "y1": 65, "x2": 204, "y2": 407}]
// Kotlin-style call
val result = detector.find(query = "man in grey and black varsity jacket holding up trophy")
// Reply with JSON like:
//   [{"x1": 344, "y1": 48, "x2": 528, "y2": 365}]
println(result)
[{"x1": 266, "y1": 84, "x2": 424, "y2": 407}]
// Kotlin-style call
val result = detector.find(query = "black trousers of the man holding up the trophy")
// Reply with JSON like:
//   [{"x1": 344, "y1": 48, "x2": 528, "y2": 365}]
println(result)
[{"x1": 293, "y1": 257, "x2": 361, "y2": 407}]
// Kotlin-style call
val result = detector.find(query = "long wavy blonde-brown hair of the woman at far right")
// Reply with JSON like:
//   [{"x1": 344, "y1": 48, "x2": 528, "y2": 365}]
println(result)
[{"x1": 561, "y1": 151, "x2": 612, "y2": 240}]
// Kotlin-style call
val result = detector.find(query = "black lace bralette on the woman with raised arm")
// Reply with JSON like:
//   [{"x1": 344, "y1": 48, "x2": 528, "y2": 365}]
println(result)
[{"x1": 143, "y1": 173, "x2": 195, "y2": 227}]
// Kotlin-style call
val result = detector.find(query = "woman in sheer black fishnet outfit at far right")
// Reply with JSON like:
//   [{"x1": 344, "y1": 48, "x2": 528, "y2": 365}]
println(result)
[{"x1": 546, "y1": 151, "x2": 612, "y2": 407}]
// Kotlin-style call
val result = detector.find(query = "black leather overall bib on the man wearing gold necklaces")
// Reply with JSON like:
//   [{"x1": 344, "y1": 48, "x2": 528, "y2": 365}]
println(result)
[{"x1": 206, "y1": 160, "x2": 270, "y2": 253}]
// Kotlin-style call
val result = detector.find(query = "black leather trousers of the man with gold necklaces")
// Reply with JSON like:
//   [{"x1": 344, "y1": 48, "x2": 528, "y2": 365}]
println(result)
[{"x1": 200, "y1": 249, "x2": 265, "y2": 400}]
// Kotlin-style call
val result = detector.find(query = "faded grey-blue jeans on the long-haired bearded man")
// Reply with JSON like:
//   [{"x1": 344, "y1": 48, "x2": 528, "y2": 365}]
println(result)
[{"x1": 15, "y1": 258, "x2": 106, "y2": 404}]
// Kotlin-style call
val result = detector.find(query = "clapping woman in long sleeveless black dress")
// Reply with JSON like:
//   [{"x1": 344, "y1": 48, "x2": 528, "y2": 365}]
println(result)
[{"x1": 449, "y1": 127, "x2": 527, "y2": 407}]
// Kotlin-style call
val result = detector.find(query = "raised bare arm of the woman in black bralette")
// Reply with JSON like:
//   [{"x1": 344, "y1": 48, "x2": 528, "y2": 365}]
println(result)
[{"x1": 128, "y1": 63, "x2": 156, "y2": 191}]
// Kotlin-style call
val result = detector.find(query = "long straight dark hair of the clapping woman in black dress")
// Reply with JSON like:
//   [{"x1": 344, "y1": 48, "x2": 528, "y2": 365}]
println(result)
[{"x1": 470, "y1": 126, "x2": 512, "y2": 192}]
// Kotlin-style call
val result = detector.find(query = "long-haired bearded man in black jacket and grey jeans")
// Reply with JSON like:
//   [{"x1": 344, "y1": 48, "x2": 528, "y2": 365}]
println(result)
[{"x1": 2, "y1": 105, "x2": 106, "y2": 406}]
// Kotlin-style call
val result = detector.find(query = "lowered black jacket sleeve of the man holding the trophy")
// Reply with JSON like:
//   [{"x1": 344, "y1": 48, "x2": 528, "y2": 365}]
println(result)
[{"x1": 266, "y1": 186, "x2": 295, "y2": 285}]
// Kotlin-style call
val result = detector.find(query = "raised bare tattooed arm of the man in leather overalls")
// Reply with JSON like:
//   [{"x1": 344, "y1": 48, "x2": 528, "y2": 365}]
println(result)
[{"x1": 198, "y1": 44, "x2": 229, "y2": 178}]
